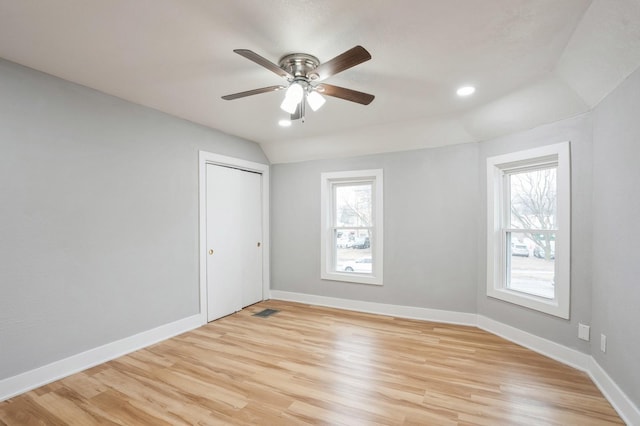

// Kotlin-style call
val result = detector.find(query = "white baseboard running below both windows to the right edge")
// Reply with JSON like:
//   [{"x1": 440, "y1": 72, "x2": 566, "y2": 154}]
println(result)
[{"x1": 271, "y1": 290, "x2": 640, "y2": 426}]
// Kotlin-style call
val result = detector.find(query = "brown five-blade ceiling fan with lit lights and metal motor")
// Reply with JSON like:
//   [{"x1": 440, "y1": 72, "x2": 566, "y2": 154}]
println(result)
[{"x1": 222, "y1": 46, "x2": 375, "y2": 122}]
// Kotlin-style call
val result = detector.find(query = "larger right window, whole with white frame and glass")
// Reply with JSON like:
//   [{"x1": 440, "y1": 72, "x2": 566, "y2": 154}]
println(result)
[{"x1": 487, "y1": 142, "x2": 571, "y2": 319}]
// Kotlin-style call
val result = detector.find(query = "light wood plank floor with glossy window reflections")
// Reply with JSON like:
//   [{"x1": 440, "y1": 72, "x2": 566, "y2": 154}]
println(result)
[{"x1": 0, "y1": 301, "x2": 622, "y2": 426}]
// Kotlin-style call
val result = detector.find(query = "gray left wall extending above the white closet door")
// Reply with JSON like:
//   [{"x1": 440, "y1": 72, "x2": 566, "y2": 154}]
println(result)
[{"x1": 0, "y1": 60, "x2": 267, "y2": 379}]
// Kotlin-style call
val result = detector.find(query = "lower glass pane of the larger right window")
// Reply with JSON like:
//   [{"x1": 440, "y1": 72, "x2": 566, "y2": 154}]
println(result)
[{"x1": 506, "y1": 232, "x2": 555, "y2": 299}]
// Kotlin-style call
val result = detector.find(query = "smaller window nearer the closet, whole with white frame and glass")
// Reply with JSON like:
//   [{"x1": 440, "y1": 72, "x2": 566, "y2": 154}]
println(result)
[{"x1": 321, "y1": 170, "x2": 383, "y2": 285}]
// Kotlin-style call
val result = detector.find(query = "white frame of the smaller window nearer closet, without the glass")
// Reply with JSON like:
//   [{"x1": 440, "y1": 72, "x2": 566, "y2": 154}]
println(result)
[{"x1": 320, "y1": 169, "x2": 384, "y2": 285}]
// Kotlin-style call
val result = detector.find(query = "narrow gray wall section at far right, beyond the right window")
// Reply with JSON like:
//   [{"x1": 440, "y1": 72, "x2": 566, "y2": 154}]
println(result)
[{"x1": 592, "y1": 65, "x2": 640, "y2": 406}]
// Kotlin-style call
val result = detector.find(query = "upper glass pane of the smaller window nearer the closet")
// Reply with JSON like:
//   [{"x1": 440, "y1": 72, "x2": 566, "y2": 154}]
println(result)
[{"x1": 334, "y1": 183, "x2": 373, "y2": 227}]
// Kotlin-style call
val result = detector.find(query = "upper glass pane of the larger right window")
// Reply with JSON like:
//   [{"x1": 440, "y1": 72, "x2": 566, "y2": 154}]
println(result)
[{"x1": 508, "y1": 167, "x2": 557, "y2": 229}]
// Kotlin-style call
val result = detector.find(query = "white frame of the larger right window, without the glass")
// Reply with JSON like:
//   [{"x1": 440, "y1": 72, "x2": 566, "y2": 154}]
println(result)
[{"x1": 487, "y1": 142, "x2": 571, "y2": 319}]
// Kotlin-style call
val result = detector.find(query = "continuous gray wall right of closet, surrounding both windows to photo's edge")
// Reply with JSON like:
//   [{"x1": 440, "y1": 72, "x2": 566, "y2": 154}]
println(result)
[{"x1": 271, "y1": 87, "x2": 640, "y2": 405}]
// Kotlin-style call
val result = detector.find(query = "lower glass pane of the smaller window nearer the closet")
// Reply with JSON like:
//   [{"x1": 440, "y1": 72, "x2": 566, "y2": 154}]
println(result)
[{"x1": 335, "y1": 229, "x2": 372, "y2": 274}]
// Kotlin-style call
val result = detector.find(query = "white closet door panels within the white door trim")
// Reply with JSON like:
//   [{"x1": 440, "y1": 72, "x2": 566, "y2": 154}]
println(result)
[{"x1": 206, "y1": 165, "x2": 262, "y2": 321}]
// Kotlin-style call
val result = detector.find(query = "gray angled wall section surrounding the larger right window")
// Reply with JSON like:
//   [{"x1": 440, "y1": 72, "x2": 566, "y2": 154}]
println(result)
[{"x1": 477, "y1": 114, "x2": 592, "y2": 353}]
